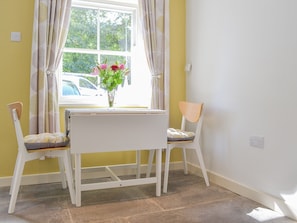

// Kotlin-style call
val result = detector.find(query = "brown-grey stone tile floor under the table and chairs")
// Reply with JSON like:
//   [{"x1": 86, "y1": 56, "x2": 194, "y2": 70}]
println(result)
[{"x1": 0, "y1": 171, "x2": 296, "y2": 223}]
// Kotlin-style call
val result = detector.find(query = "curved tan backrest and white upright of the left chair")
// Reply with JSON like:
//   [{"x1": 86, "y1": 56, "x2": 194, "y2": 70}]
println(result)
[{"x1": 7, "y1": 101, "x2": 26, "y2": 151}]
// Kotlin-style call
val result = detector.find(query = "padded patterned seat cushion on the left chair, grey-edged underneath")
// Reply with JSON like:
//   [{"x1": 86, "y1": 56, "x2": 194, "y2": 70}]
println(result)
[{"x1": 24, "y1": 132, "x2": 69, "y2": 149}]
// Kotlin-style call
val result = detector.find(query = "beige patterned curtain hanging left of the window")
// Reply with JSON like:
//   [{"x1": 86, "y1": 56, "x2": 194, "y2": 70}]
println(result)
[{"x1": 30, "y1": 0, "x2": 71, "y2": 134}]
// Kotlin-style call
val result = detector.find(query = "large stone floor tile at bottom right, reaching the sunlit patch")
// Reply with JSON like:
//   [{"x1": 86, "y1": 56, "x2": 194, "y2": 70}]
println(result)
[{"x1": 129, "y1": 196, "x2": 295, "y2": 223}]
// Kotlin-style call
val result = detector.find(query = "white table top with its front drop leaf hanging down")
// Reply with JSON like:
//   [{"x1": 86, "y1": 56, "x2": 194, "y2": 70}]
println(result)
[{"x1": 65, "y1": 109, "x2": 168, "y2": 153}]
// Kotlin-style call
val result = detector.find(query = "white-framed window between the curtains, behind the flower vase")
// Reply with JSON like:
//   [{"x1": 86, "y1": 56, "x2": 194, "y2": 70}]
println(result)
[{"x1": 59, "y1": 0, "x2": 151, "y2": 107}]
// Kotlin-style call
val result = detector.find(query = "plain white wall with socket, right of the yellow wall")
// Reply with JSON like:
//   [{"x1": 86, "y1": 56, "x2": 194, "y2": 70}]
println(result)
[{"x1": 186, "y1": 0, "x2": 297, "y2": 215}]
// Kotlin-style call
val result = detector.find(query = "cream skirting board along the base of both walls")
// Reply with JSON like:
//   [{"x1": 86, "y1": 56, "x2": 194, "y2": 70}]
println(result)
[{"x1": 0, "y1": 162, "x2": 297, "y2": 220}]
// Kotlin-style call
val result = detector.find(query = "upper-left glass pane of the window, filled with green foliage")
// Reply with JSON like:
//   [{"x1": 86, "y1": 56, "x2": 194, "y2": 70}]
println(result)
[{"x1": 66, "y1": 7, "x2": 98, "y2": 49}]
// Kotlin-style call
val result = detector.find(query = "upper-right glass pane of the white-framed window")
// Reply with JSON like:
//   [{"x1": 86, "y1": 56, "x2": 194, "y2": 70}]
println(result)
[{"x1": 99, "y1": 10, "x2": 132, "y2": 52}]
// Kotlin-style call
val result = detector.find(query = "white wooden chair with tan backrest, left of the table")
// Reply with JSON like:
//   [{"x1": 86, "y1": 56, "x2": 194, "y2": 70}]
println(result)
[{"x1": 8, "y1": 102, "x2": 75, "y2": 214}]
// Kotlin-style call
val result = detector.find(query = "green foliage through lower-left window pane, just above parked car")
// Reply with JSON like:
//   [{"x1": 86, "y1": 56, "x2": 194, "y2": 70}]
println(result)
[{"x1": 63, "y1": 53, "x2": 98, "y2": 74}]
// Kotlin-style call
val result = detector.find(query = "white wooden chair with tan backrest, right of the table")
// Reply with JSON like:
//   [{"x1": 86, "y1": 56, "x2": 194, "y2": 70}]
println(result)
[{"x1": 147, "y1": 101, "x2": 209, "y2": 193}]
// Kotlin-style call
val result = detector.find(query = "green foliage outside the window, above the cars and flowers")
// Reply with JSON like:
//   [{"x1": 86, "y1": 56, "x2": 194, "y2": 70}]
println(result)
[{"x1": 63, "y1": 7, "x2": 132, "y2": 74}]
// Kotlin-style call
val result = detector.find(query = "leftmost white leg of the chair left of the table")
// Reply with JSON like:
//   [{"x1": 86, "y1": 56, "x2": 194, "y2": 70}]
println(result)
[{"x1": 8, "y1": 154, "x2": 25, "y2": 214}]
